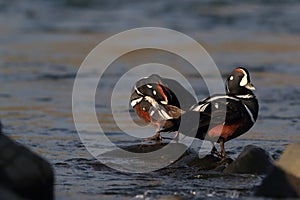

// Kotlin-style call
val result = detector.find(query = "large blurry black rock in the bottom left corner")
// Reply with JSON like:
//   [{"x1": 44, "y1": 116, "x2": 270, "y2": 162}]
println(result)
[{"x1": 0, "y1": 125, "x2": 54, "y2": 200}]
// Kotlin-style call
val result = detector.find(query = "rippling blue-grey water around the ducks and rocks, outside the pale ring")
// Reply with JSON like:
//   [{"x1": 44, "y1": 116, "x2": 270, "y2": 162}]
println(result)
[{"x1": 0, "y1": 0, "x2": 300, "y2": 199}]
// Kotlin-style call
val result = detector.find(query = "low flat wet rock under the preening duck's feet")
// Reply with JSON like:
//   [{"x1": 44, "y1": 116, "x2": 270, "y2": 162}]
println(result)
[{"x1": 97, "y1": 143, "x2": 188, "y2": 173}]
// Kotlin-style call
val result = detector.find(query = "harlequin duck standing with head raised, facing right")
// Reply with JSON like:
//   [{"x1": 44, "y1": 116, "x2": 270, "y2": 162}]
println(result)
[{"x1": 160, "y1": 67, "x2": 259, "y2": 158}]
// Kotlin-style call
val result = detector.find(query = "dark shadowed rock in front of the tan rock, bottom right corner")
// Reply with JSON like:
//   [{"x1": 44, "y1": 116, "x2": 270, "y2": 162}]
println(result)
[{"x1": 255, "y1": 166, "x2": 300, "y2": 198}]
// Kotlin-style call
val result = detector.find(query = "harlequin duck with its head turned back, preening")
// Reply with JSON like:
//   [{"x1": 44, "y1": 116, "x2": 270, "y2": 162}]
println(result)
[{"x1": 130, "y1": 74, "x2": 196, "y2": 141}]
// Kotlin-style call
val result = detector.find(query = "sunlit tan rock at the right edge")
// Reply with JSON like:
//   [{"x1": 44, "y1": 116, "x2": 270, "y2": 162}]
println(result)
[{"x1": 276, "y1": 143, "x2": 300, "y2": 178}]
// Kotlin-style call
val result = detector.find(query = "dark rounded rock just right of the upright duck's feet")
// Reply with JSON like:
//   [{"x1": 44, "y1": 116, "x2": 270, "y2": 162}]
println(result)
[{"x1": 223, "y1": 145, "x2": 273, "y2": 174}]
